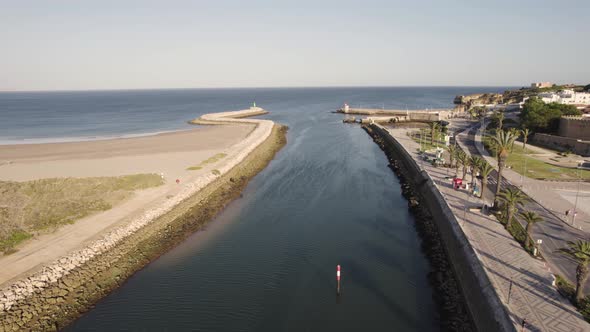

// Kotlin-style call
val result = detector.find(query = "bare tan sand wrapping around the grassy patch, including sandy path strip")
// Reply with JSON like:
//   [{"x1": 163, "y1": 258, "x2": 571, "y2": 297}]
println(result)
[{"x1": 0, "y1": 124, "x2": 255, "y2": 285}]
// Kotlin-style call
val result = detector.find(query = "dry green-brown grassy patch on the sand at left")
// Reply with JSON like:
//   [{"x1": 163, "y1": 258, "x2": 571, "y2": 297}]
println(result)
[{"x1": 0, "y1": 174, "x2": 164, "y2": 253}]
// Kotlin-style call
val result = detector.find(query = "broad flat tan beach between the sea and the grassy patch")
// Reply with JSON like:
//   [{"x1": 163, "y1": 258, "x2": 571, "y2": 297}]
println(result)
[{"x1": 0, "y1": 124, "x2": 254, "y2": 181}]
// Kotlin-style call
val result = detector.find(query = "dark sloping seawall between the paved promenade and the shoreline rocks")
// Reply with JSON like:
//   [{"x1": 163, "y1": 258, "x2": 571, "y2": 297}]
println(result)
[{"x1": 365, "y1": 124, "x2": 514, "y2": 331}]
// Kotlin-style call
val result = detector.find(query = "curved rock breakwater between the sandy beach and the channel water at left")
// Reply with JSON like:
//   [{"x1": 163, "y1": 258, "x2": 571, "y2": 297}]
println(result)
[{"x1": 0, "y1": 108, "x2": 286, "y2": 332}]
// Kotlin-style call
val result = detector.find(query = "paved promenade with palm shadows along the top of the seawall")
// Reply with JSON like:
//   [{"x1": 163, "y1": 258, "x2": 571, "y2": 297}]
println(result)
[{"x1": 389, "y1": 129, "x2": 590, "y2": 332}]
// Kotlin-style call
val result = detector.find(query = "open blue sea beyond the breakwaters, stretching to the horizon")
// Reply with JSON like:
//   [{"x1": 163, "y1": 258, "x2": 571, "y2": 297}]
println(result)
[{"x1": 0, "y1": 87, "x2": 504, "y2": 144}]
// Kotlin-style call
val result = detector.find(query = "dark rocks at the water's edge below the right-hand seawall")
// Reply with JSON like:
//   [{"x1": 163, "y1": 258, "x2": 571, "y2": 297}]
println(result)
[{"x1": 362, "y1": 126, "x2": 476, "y2": 331}]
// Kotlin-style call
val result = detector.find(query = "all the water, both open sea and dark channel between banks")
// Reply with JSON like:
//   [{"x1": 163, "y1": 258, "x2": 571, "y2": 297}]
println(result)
[{"x1": 0, "y1": 87, "x2": 503, "y2": 331}]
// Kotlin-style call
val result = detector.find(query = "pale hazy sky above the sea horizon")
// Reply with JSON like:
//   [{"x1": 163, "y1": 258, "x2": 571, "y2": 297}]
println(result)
[{"x1": 0, "y1": 0, "x2": 590, "y2": 91}]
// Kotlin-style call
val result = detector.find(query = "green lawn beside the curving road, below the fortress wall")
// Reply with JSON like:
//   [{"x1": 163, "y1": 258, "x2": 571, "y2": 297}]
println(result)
[{"x1": 482, "y1": 136, "x2": 590, "y2": 180}]
